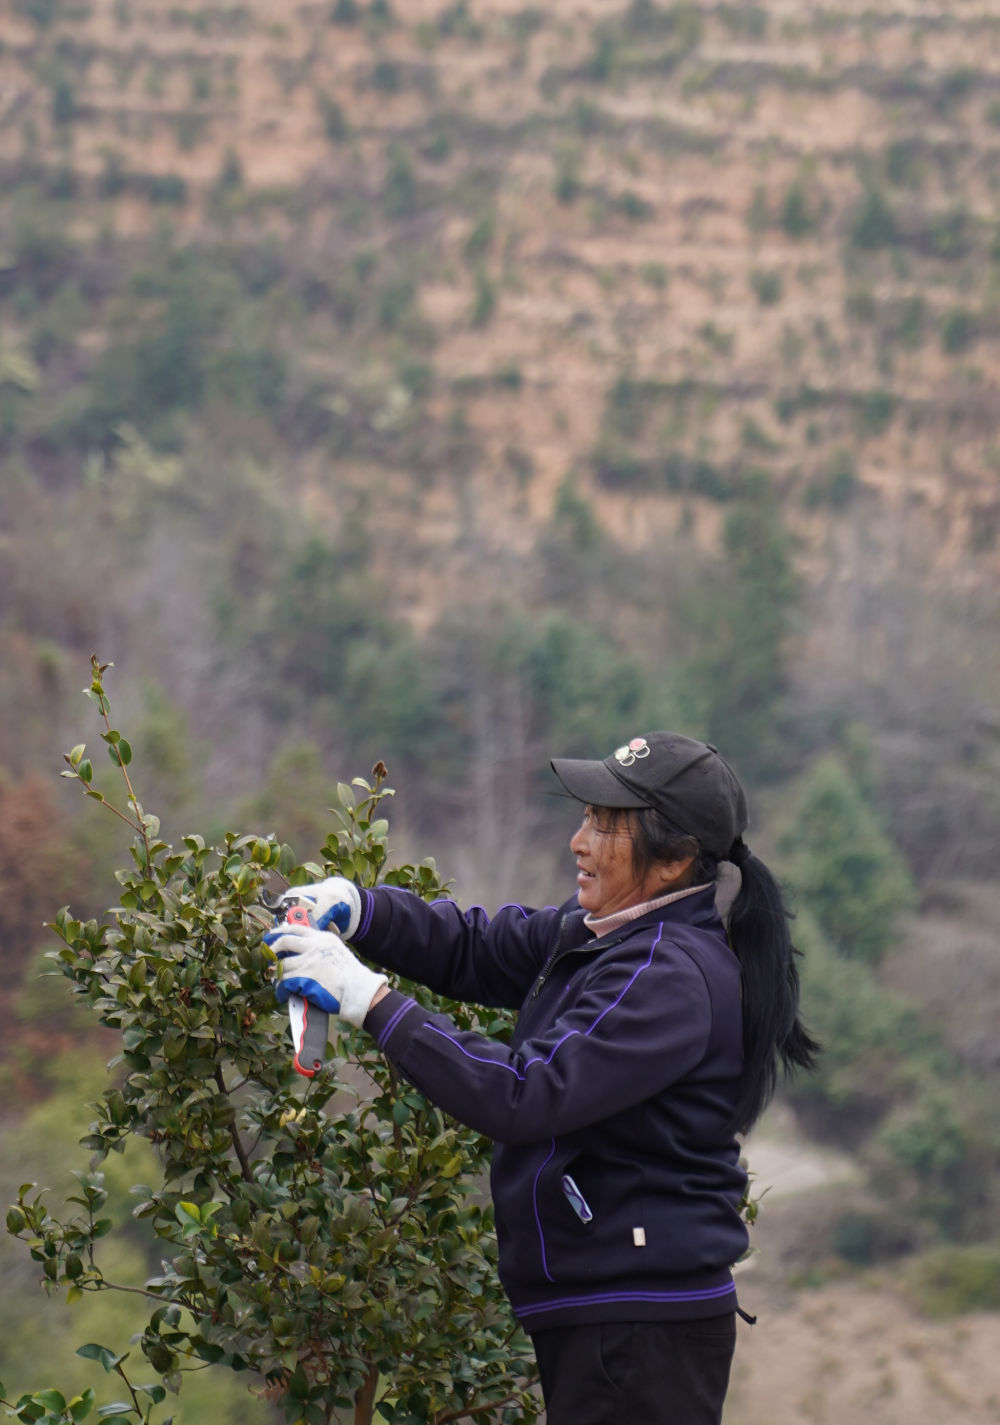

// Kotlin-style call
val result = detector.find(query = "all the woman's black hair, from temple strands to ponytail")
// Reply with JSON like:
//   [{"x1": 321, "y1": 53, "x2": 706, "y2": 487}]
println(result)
[{"x1": 629, "y1": 807, "x2": 821, "y2": 1134}]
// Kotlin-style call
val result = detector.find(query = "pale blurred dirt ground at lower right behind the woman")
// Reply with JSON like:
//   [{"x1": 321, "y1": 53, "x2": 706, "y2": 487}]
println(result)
[{"x1": 725, "y1": 1126, "x2": 1000, "y2": 1425}]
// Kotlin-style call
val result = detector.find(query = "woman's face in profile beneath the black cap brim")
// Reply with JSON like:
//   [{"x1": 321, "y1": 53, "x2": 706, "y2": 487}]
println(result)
[{"x1": 570, "y1": 807, "x2": 691, "y2": 916}]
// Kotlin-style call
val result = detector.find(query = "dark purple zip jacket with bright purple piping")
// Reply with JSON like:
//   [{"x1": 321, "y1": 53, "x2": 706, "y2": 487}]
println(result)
[{"x1": 352, "y1": 886, "x2": 746, "y2": 1331}]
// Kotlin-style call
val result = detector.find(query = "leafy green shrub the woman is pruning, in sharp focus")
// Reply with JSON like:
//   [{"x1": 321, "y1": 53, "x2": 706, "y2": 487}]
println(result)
[{"x1": 7, "y1": 658, "x2": 538, "y2": 1425}]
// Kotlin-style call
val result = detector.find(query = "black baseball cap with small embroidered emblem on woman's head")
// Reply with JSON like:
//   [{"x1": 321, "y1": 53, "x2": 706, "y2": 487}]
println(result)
[{"x1": 551, "y1": 732, "x2": 748, "y2": 861}]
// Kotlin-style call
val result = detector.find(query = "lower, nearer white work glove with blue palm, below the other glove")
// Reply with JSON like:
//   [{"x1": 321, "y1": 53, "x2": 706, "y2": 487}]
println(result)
[{"x1": 264, "y1": 922, "x2": 387, "y2": 1026}]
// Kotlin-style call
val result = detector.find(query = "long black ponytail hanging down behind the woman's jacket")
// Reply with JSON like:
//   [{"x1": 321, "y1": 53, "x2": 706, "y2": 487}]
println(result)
[{"x1": 728, "y1": 836, "x2": 821, "y2": 1133}]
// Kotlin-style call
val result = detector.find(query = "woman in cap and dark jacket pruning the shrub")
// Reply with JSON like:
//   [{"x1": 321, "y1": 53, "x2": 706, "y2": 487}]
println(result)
[{"x1": 268, "y1": 732, "x2": 818, "y2": 1425}]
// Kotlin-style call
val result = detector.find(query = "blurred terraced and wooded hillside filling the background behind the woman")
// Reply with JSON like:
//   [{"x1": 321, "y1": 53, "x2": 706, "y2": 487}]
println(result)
[{"x1": 0, "y1": 0, "x2": 1000, "y2": 1418}]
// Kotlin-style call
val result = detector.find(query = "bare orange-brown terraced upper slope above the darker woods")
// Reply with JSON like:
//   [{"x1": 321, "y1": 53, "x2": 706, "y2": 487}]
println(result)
[{"x1": 0, "y1": 0, "x2": 1000, "y2": 586}]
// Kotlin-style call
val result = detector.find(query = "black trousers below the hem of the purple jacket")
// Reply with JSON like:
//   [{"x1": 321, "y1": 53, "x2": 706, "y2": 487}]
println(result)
[{"x1": 531, "y1": 1312, "x2": 736, "y2": 1425}]
